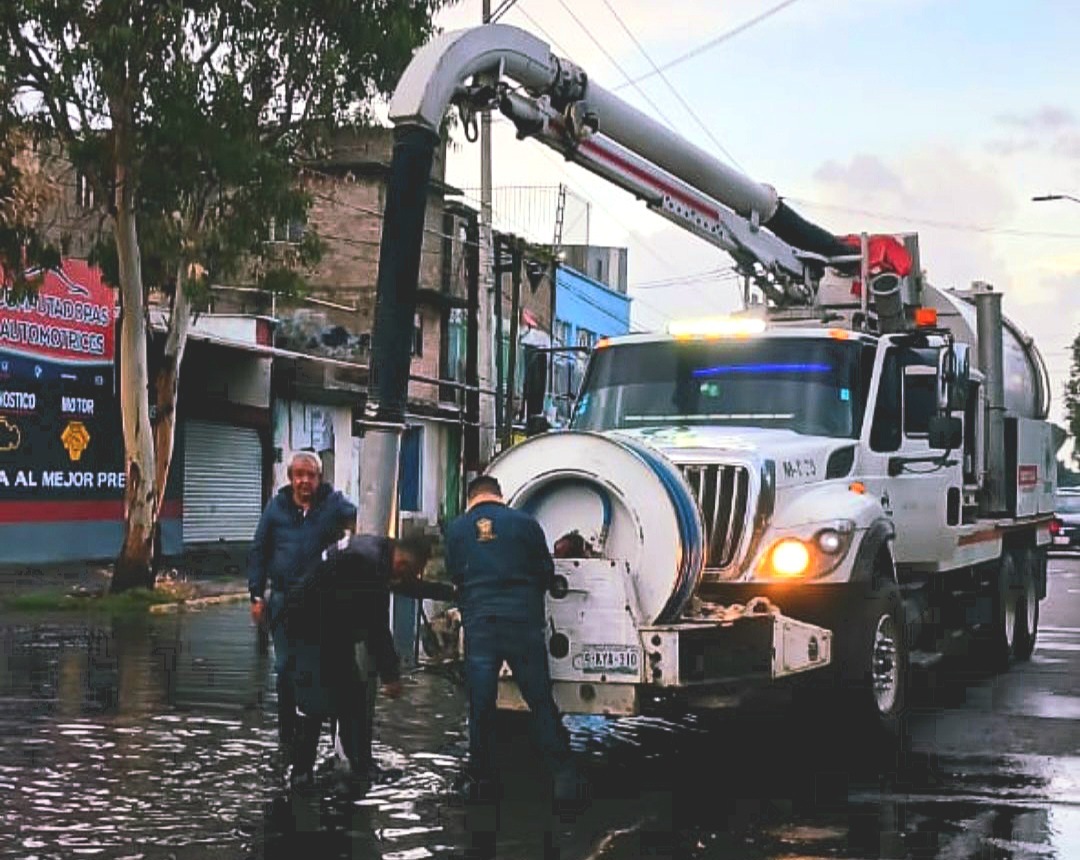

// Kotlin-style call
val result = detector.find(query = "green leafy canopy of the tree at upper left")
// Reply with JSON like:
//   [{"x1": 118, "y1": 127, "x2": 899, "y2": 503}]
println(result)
[{"x1": 0, "y1": 0, "x2": 446, "y2": 298}]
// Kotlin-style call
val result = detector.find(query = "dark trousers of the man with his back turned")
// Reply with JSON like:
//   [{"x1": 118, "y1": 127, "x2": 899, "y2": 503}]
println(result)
[{"x1": 465, "y1": 619, "x2": 569, "y2": 780}]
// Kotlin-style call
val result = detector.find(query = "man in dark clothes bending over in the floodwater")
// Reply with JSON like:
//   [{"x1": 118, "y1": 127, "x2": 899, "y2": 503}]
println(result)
[{"x1": 280, "y1": 535, "x2": 454, "y2": 784}]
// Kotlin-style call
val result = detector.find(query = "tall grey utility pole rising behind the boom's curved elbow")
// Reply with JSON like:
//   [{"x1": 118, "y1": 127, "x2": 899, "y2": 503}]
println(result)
[{"x1": 476, "y1": 0, "x2": 502, "y2": 466}]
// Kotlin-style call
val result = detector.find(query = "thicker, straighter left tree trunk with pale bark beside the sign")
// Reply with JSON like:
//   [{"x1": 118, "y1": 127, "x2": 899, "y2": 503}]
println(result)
[{"x1": 109, "y1": 160, "x2": 158, "y2": 593}]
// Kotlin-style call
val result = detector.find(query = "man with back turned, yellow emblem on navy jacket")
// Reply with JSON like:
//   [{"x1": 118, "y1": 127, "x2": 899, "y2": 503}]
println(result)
[{"x1": 446, "y1": 475, "x2": 572, "y2": 793}]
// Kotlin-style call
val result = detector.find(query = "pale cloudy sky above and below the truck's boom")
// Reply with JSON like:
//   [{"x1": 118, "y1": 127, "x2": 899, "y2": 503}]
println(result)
[{"x1": 429, "y1": 0, "x2": 1080, "y2": 434}]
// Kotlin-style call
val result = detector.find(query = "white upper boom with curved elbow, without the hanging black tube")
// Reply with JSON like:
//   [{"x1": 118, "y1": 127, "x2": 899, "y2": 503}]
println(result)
[{"x1": 390, "y1": 24, "x2": 851, "y2": 304}]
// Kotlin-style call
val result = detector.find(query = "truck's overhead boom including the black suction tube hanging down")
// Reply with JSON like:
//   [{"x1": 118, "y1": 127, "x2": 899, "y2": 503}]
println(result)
[{"x1": 356, "y1": 24, "x2": 851, "y2": 535}]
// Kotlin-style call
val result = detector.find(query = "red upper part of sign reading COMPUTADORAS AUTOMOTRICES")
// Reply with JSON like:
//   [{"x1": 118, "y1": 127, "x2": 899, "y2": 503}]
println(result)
[{"x1": 0, "y1": 259, "x2": 116, "y2": 364}]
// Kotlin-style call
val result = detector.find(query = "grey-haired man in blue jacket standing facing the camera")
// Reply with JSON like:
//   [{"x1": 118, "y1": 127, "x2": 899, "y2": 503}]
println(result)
[{"x1": 247, "y1": 451, "x2": 358, "y2": 782}]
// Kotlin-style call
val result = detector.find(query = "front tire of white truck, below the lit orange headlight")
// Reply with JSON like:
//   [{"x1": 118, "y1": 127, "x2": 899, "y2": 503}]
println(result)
[{"x1": 837, "y1": 575, "x2": 908, "y2": 740}]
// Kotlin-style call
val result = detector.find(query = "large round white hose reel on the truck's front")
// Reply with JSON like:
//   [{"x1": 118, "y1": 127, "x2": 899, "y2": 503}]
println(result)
[{"x1": 487, "y1": 430, "x2": 705, "y2": 624}]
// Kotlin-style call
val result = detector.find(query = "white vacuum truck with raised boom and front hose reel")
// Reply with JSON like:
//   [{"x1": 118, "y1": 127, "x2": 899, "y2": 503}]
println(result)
[{"x1": 361, "y1": 25, "x2": 1059, "y2": 733}]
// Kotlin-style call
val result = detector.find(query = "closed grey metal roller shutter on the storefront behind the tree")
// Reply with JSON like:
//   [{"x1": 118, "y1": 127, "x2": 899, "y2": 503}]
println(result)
[{"x1": 184, "y1": 421, "x2": 262, "y2": 543}]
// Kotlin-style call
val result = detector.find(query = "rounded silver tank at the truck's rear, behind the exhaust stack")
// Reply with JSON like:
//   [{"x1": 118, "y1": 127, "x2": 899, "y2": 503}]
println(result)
[{"x1": 922, "y1": 284, "x2": 1050, "y2": 419}]
